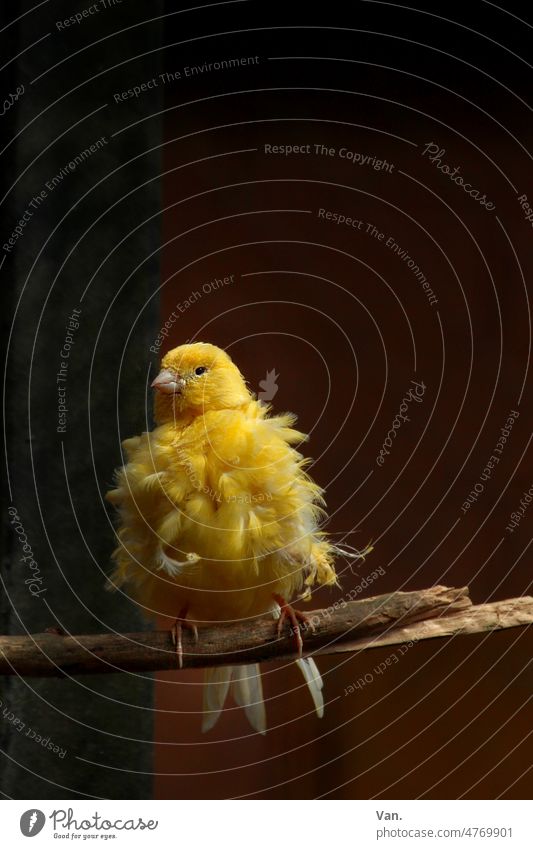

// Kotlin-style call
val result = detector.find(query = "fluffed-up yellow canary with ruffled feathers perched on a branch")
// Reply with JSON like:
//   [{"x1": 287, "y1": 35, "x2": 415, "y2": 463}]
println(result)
[{"x1": 107, "y1": 343, "x2": 359, "y2": 733}]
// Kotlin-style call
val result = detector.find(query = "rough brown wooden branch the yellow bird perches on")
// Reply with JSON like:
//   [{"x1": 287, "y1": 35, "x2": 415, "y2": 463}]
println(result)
[{"x1": 0, "y1": 586, "x2": 533, "y2": 676}]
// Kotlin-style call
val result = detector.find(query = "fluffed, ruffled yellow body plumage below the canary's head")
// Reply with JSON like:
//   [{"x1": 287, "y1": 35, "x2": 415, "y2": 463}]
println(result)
[{"x1": 109, "y1": 401, "x2": 335, "y2": 618}]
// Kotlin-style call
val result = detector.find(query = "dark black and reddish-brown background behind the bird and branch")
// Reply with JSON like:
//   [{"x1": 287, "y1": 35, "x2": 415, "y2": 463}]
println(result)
[{"x1": 0, "y1": 2, "x2": 533, "y2": 798}]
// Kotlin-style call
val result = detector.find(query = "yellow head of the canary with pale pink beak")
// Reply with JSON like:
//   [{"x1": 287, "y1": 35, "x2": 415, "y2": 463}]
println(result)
[{"x1": 152, "y1": 342, "x2": 251, "y2": 424}]
